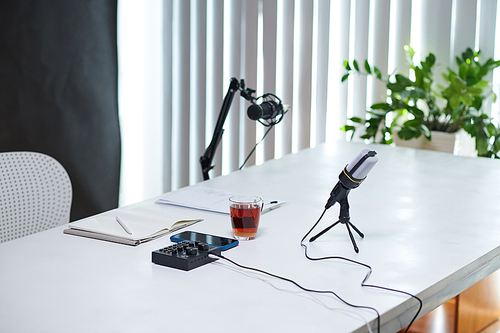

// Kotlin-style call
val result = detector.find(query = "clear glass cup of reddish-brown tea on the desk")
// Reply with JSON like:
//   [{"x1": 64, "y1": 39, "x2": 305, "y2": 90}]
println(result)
[{"x1": 229, "y1": 195, "x2": 263, "y2": 240}]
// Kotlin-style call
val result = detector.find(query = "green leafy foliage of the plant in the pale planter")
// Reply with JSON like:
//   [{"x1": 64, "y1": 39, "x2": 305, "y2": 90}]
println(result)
[{"x1": 342, "y1": 46, "x2": 500, "y2": 158}]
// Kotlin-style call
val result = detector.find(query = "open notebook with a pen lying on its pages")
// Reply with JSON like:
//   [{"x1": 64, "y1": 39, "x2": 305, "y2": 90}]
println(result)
[{"x1": 63, "y1": 207, "x2": 202, "y2": 245}]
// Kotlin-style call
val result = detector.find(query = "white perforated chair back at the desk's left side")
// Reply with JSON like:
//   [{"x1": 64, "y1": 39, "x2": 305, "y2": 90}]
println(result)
[{"x1": 0, "y1": 152, "x2": 73, "y2": 243}]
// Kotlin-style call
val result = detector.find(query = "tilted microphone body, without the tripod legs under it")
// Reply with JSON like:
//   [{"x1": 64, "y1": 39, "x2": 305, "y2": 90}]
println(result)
[{"x1": 325, "y1": 148, "x2": 378, "y2": 209}]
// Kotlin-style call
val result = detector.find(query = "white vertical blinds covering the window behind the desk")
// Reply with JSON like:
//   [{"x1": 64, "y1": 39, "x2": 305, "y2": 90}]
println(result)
[{"x1": 118, "y1": 0, "x2": 500, "y2": 205}]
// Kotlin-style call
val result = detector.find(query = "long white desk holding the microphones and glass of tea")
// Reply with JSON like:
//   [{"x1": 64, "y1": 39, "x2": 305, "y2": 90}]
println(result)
[{"x1": 0, "y1": 142, "x2": 500, "y2": 332}]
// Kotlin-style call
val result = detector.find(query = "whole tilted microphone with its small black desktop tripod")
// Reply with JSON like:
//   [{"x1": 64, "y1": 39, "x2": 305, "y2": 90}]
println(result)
[{"x1": 309, "y1": 148, "x2": 378, "y2": 253}]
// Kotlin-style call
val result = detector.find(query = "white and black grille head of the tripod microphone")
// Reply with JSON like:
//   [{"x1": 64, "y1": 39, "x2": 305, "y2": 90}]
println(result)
[{"x1": 339, "y1": 148, "x2": 378, "y2": 188}]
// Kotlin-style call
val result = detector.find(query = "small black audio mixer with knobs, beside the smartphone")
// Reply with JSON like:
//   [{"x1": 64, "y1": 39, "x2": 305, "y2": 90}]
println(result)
[{"x1": 152, "y1": 241, "x2": 221, "y2": 271}]
